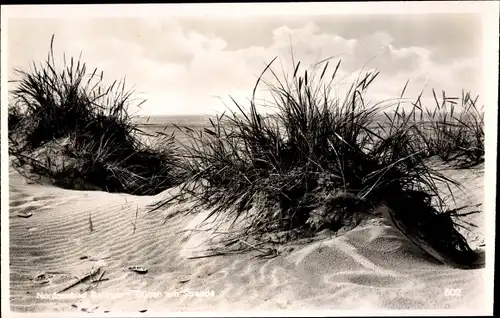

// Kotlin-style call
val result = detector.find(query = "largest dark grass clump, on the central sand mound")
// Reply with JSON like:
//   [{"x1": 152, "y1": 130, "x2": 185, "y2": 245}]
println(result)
[{"x1": 150, "y1": 56, "x2": 482, "y2": 264}]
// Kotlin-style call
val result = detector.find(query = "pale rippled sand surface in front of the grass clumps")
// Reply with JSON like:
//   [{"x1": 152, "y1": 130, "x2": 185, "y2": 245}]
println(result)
[{"x1": 9, "y1": 160, "x2": 484, "y2": 315}]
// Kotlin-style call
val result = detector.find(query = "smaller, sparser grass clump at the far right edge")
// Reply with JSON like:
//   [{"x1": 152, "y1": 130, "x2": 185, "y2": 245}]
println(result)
[{"x1": 415, "y1": 90, "x2": 484, "y2": 168}]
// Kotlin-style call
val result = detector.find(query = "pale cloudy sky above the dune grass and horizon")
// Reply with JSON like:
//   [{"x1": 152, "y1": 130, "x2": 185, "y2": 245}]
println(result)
[{"x1": 4, "y1": 3, "x2": 492, "y2": 115}]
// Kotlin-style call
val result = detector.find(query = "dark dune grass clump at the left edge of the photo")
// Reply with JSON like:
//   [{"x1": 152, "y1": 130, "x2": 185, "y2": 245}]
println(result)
[{"x1": 9, "y1": 37, "x2": 184, "y2": 195}]
